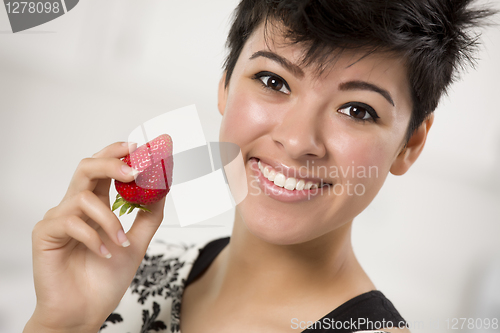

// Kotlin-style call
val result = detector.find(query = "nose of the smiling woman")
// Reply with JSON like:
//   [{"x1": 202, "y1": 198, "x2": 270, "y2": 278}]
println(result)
[{"x1": 272, "y1": 105, "x2": 326, "y2": 159}]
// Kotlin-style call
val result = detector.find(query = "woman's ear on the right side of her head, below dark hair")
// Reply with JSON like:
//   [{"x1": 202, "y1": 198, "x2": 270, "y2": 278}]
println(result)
[{"x1": 390, "y1": 113, "x2": 434, "y2": 176}]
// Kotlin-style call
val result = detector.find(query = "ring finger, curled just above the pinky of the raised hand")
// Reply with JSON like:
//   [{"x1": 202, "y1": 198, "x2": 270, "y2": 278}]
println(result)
[{"x1": 59, "y1": 191, "x2": 130, "y2": 247}]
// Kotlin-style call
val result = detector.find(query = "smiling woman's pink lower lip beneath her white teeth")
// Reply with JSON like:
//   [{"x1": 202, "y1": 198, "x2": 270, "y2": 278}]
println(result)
[{"x1": 248, "y1": 158, "x2": 323, "y2": 202}]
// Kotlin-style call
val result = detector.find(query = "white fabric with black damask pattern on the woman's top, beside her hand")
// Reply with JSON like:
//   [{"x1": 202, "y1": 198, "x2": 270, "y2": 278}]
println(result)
[{"x1": 99, "y1": 242, "x2": 205, "y2": 333}]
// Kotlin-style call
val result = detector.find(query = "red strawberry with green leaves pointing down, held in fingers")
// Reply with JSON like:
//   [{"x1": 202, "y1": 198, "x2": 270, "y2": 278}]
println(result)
[{"x1": 112, "y1": 134, "x2": 174, "y2": 216}]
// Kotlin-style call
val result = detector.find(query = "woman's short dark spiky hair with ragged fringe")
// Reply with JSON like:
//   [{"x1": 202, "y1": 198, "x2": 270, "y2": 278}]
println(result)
[{"x1": 223, "y1": 0, "x2": 496, "y2": 143}]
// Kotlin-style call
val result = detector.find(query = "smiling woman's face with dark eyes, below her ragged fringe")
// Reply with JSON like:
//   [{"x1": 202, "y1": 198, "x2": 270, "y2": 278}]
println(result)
[{"x1": 219, "y1": 25, "x2": 411, "y2": 244}]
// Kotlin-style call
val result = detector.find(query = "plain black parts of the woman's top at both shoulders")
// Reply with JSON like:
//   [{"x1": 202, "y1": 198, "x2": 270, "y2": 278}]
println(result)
[{"x1": 185, "y1": 237, "x2": 406, "y2": 333}]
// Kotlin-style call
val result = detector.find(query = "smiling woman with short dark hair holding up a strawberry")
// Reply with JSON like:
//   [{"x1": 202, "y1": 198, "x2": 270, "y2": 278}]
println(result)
[{"x1": 25, "y1": 0, "x2": 491, "y2": 333}]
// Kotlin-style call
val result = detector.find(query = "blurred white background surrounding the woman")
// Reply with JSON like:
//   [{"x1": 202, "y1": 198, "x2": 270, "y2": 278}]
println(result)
[{"x1": 0, "y1": 0, "x2": 500, "y2": 333}]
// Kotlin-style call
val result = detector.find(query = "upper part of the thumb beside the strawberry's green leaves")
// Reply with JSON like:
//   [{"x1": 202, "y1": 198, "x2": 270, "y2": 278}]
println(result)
[{"x1": 127, "y1": 198, "x2": 166, "y2": 253}]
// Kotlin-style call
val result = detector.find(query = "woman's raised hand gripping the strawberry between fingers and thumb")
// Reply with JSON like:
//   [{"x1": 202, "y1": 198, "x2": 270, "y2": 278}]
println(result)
[{"x1": 24, "y1": 143, "x2": 165, "y2": 333}]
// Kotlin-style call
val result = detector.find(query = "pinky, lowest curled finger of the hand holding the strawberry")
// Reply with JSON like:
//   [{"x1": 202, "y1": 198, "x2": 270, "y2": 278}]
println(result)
[{"x1": 33, "y1": 215, "x2": 111, "y2": 259}]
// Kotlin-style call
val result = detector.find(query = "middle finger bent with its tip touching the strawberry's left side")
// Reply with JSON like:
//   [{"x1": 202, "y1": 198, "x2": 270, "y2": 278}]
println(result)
[{"x1": 66, "y1": 157, "x2": 137, "y2": 197}]
